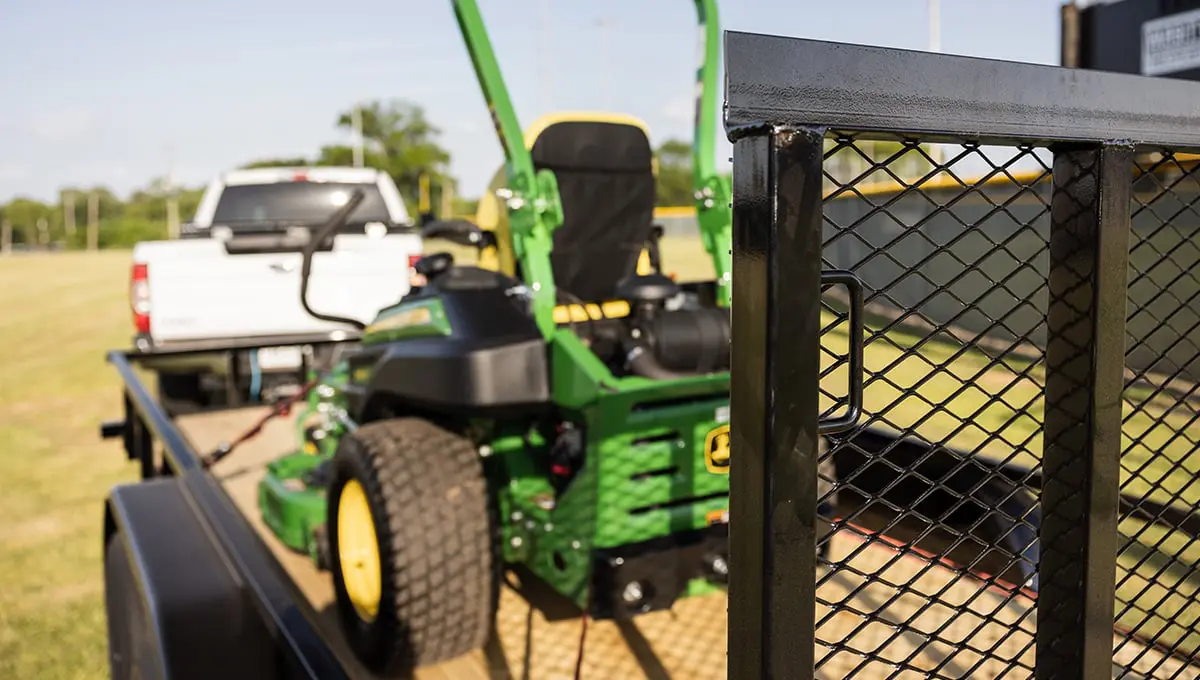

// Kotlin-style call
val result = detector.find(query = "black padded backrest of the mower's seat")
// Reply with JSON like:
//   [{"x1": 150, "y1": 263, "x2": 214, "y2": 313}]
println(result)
[{"x1": 530, "y1": 120, "x2": 655, "y2": 302}]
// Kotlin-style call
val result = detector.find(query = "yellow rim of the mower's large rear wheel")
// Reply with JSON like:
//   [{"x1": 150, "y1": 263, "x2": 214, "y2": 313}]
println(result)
[{"x1": 337, "y1": 480, "x2": 383, "y2": 624}]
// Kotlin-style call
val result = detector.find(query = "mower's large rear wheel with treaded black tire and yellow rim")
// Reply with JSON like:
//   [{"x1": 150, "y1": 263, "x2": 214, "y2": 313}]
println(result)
[{"x1": 325, "y1": 417, "x2": 500, "y2": 676}]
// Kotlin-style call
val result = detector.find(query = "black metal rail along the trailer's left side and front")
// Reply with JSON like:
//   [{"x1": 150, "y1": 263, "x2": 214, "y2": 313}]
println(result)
[{"x1": 101, "y1": 341, "x2": 349, "y2": 679}]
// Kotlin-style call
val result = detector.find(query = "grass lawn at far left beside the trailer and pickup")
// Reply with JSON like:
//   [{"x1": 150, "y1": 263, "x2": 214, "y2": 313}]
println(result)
[{"x1": 0, "y1": 252, "x2": 137, "y2": 680}]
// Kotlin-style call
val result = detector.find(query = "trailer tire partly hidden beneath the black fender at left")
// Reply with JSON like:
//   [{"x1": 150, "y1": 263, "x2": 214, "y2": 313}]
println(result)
[{"x1": 104, "y1": 531, "x2": 163, "y2": 680}]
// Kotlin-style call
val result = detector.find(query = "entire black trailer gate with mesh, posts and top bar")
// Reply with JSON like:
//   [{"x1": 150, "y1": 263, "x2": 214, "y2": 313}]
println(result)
[{"x1": 726, "y1": 32, "x2": 1200, "y2": 679}]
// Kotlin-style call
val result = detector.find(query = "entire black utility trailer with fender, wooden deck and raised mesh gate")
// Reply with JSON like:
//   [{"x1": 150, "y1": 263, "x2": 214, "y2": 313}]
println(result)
[{"x1": 104, "y1": 5, "x2": 1200, "y2": 679}]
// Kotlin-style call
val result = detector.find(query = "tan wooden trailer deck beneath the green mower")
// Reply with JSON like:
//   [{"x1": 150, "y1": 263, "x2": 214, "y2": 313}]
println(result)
[{"x1": 179, "y1": 408, "x2": 1200, "y2": 680}]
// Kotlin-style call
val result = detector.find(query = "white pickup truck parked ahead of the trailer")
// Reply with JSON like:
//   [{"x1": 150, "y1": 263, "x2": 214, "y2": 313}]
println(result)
[{"x1": 130, "y1": 167, "x2": 421, "y2": 413}]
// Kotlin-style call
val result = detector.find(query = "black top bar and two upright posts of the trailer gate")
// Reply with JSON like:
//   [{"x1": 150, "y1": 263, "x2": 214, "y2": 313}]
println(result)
[{"x1": 725, "y1": 32, "x2": 1200, "y2": 680}]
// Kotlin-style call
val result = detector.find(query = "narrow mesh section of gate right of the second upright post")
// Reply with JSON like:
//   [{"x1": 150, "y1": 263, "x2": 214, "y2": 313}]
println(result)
[{"x1": 1115, "y1": 151, "x2": 1200, "y2": 678}]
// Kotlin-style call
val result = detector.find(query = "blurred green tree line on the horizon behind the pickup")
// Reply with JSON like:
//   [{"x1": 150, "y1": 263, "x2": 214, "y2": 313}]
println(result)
[{"x1": 0, "y1": 100, "x2": 692, "y2": 248}]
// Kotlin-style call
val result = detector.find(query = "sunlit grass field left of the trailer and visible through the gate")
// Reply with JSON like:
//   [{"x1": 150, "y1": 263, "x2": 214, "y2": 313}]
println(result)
[{"x1": 0, "y1": 239, "x2": 1200, "y2": 680}]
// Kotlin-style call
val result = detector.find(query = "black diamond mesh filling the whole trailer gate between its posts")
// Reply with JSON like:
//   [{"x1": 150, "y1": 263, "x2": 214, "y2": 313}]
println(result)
[{"x1": 816, "y1": 134, "x2": 1200, "y2": 678}]
